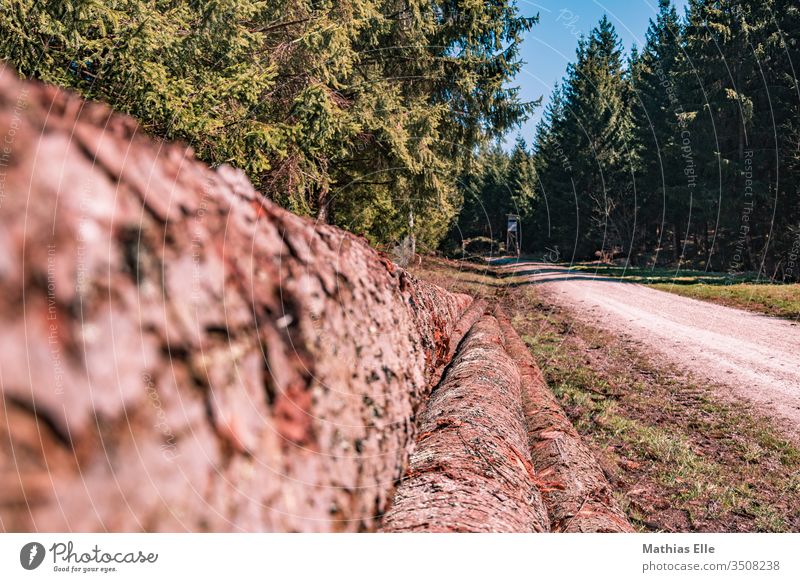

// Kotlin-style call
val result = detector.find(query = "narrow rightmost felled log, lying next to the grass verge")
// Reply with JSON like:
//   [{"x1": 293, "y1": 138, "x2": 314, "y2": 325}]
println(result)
[{"x1": 496, "y1": 310, "x2": 633, "y2": 532}]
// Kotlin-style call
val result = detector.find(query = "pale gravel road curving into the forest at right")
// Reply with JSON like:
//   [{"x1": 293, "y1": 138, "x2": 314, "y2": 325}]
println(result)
[{"x1": 497, "y1": 262, "x2": 800, "y2": 434}]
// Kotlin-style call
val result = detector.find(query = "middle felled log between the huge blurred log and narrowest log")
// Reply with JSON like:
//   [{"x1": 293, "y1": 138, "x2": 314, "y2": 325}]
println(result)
[{"x1": 383, "y1": 316, "x2": 548, "y2": 532}]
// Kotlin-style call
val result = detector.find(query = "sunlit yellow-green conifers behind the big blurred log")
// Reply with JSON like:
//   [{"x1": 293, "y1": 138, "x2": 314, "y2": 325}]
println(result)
[{"x1": 0, "y1": 0, "x2": 535, "y2": 245}]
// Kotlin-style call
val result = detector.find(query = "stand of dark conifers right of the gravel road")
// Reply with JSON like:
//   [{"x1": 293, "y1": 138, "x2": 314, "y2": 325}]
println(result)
[{"x1": 527, "y1": 0, "x2": 800, "y2": 279}]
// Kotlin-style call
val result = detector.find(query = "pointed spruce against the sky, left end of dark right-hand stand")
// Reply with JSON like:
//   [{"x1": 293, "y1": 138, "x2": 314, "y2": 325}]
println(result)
[{"x1": 536, "y1": 16, "x2": 635, "y2": 257}]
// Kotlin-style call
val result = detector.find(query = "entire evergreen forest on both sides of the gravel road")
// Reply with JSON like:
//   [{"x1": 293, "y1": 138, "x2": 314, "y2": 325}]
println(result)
[{"x1": 7, "y1": 0, "x2": 800, "y2": 279}]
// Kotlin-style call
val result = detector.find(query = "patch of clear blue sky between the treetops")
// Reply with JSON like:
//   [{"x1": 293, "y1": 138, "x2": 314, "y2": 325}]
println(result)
[{"x1": 508, "y1": 0, "x2": 686, "y2": 144}]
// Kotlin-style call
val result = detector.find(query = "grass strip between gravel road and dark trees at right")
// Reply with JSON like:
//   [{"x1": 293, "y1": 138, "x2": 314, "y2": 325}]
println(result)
[{"x1": 569, "y1": 263, "x2": 800, "y2": 319}]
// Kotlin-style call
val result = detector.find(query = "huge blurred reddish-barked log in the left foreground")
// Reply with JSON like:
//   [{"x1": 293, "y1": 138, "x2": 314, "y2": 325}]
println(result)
[{"x1": 0, "y1": 73, "x2": 472, "y2": 531}]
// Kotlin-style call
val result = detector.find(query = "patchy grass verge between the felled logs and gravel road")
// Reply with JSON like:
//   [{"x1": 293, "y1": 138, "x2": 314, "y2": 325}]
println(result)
[{"x1": 415, "y1": 261, "x2": 800, "y2": 532}]
